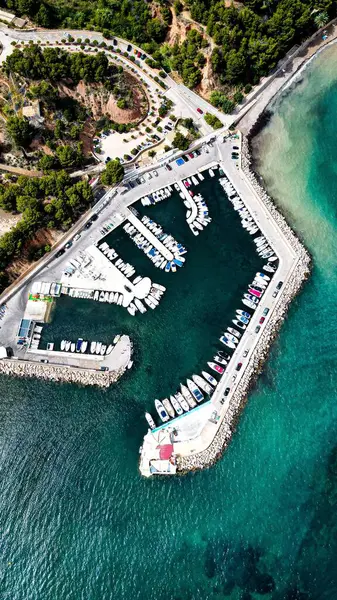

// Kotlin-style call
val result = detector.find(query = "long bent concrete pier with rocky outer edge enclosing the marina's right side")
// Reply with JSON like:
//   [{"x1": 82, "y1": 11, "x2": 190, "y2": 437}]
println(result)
[{"x1": 140, "y1": 139, "x2": 310, "y2": 477}]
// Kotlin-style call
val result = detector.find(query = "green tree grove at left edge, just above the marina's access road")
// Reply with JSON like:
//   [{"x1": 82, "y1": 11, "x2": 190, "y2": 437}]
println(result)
[{"x1": 0, "y1": 171, "x2": 93, "y2": 278}]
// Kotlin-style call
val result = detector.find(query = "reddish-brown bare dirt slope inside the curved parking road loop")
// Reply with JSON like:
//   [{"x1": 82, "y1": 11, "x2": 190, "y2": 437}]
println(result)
[{"x1": 58, "y1": 75, "x2": 144, "y2": 123}]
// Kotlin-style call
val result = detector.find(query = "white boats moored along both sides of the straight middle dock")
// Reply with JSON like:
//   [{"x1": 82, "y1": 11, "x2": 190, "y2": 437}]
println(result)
[{"x1": 124, "y1": 215, "x2": 187, "y2": 273}]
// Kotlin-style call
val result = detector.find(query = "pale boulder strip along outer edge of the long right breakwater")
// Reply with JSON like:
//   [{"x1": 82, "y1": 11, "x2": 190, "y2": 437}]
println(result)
[{"x1": 176, "y1": 136, "x2": 311, "y2": 474}]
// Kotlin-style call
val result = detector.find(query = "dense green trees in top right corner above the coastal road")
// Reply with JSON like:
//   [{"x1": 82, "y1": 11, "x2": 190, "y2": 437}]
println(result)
[{"x1": 190, "y1": 0, "x2": 336, "y2": 85}]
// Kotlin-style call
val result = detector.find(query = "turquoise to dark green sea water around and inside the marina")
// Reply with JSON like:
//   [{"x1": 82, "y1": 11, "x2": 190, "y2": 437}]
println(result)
[{"x1": 0, "y1": 44, "x2": 337, "y2": 600}]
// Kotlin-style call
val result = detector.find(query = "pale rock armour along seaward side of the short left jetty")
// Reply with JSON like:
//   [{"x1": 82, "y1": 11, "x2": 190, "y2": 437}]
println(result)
[{"x1": 0, "y1": 358, "x2": 125, "y2": 388}]
